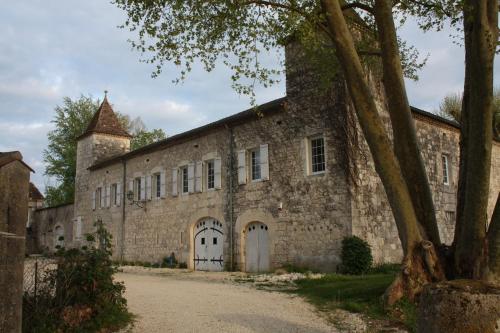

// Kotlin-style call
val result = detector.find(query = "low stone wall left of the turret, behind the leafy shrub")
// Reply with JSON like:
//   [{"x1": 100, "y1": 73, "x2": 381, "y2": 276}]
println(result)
[{"x1": 31, "y1": 204, "x2": 76, "y2": 253}]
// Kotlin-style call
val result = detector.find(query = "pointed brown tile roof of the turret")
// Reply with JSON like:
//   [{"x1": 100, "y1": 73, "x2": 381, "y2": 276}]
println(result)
[{"x1": 78, "y1": 97, "x2": 132, "y2": 140}]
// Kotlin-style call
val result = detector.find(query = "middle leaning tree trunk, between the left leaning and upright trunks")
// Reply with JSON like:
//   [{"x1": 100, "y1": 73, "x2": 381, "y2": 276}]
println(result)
[{"x1": 374, "y1": 0, "x2": 441, "y2": 247}]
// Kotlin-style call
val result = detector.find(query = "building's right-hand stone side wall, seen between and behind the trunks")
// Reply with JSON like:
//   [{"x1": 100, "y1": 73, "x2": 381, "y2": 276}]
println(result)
[{"x1": 353, "y1": 113, "x2": 500, "y2": 263}]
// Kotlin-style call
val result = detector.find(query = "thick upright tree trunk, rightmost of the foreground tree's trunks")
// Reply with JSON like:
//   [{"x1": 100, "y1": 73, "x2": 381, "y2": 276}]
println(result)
[{"x1": 454, "y1": 0, "x2": 498, "y2": 279}]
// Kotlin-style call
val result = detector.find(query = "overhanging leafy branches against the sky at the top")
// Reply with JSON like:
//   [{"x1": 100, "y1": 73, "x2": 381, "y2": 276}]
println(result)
[{"x1": 114, "y1": 0, "x2": 425, "y2": 101}]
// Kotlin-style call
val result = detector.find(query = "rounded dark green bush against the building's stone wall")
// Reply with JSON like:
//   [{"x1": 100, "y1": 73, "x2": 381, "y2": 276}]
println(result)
[{"x1": 340, "y1": 236, "x2": 373, "y2": 275}]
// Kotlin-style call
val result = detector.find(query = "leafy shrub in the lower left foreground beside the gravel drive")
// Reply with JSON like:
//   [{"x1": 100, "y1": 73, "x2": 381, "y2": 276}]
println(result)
[{"x1": 23, "y1": 222, "x2": 132, "y2": 333}]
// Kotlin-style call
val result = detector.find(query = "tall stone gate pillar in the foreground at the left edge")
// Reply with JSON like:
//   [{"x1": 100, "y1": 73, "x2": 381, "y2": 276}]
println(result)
[{"x1": 0, "y1": 151, "x2": 34, "y2": 332}]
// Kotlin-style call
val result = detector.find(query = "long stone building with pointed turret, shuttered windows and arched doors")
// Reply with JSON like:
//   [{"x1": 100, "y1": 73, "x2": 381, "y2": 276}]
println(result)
[{"x1": 32, "y1": 47, "x2": 500, "y2": 271}]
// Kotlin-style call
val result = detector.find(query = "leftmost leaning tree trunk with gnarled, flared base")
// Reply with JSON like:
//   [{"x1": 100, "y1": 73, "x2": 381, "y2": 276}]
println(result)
[{"x1": 322, "y1": 0, "x2": 442, "y2": 304}]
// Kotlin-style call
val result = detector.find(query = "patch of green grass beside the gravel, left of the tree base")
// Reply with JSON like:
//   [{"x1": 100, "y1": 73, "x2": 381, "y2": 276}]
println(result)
[{"x1": 292, "y1": 272, "x2": 416, "y2": 332}]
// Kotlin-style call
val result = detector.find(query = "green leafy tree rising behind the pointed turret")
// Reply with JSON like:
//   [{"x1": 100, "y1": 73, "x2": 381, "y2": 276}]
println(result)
[{"x1": 43, "y1": 95, "x2": 166, "y2": 206}]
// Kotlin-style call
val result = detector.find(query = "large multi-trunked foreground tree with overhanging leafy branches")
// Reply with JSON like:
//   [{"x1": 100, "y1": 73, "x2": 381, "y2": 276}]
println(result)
[{"x1": 115, "y1": 0, "x2": 500, "y2": 304}]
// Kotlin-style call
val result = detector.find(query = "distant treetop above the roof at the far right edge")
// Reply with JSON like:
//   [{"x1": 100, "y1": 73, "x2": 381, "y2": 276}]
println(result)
[{"x1": 438, "y1": 88, "x2": 500, "y2": 141}]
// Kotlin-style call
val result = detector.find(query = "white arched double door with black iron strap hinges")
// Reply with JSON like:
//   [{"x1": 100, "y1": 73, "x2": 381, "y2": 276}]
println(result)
[{"x1": 194, "y1": 218, "x2": 224, "y2": 271}]
